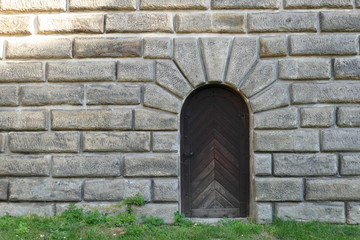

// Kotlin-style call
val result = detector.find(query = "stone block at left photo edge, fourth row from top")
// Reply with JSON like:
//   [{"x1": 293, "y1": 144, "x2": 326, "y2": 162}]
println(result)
[{"x1": 0, "y1": 62, "x2": 45, "y2": 83}]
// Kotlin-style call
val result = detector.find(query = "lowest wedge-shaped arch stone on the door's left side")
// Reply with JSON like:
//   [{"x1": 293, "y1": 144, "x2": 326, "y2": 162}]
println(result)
[{"x1": 144, "y1": 84, "x2": 182, "y2": 113}]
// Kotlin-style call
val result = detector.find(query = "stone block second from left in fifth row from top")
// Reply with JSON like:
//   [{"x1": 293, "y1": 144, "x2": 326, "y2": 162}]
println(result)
[{"x1": 20, "y1": 84, "x2": 84, "y2": 106}]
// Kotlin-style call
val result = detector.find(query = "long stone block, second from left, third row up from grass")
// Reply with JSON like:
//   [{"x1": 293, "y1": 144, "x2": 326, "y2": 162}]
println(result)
[{"x1": 51, "y1": 155, "x2": 120, "y2": 177}]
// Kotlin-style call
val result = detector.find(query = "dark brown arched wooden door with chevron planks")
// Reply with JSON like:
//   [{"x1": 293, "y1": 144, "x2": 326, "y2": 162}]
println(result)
[{"x1": 181, "y1": 85, "x2": 249, "y2": 218}]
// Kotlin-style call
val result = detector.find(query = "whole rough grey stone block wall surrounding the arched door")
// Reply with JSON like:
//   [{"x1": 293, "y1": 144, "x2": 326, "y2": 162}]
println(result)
[{"x1": 0, "y1": 0, "x2": 360, "y2": 224}]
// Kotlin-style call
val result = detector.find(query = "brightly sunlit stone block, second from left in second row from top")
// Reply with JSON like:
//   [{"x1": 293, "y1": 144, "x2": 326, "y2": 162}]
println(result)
[{"x1": 38, "y1": 13, "x2": 104, "y2": 34}]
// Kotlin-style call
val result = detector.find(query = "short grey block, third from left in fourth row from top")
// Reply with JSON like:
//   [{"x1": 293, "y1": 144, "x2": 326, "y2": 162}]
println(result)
[{"x1": 117, "y1": 60, "x2": 154, "y2": 82}]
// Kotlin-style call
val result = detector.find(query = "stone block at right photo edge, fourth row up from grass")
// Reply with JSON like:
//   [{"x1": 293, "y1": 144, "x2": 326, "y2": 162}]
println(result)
[{"x1": 321, "y1": 129, "x2": 360, "y2": 152}]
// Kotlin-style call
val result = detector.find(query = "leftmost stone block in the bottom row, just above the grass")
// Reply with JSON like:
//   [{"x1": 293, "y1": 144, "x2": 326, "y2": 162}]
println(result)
[{"x1": 0, "y1": 203, "x2": 54, "y2": 217}]
